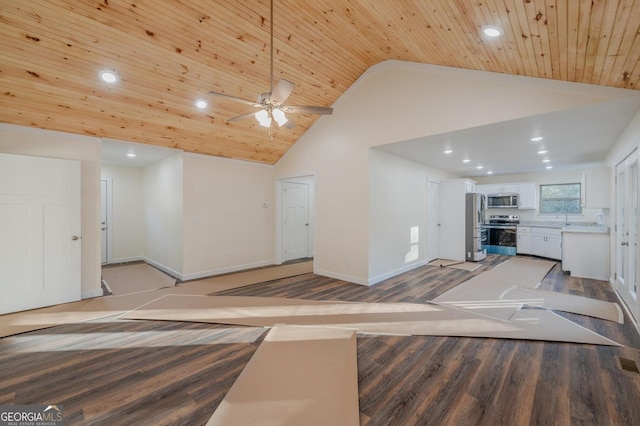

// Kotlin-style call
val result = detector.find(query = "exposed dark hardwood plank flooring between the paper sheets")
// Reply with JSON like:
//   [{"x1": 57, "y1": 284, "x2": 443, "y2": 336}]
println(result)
[{"x1": 0, "y1": 255, "x2": 640, "y2": 425}]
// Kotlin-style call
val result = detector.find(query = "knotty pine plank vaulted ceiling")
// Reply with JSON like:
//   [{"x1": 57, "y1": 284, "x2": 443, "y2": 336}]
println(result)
[{"x1": 0, "y1": 0, "x2": 640, "y2": 164}]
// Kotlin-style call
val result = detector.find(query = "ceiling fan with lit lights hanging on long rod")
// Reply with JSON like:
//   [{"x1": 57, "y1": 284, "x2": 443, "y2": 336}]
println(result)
[{"x1": 209, "y1": 0, "x2": 333, "y2": 129}]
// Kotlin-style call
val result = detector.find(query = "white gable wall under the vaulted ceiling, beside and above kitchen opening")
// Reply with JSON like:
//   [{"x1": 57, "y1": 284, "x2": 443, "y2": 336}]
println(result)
[{"x1": 276, "y1": 61, "x2": 624, "y2": 284}]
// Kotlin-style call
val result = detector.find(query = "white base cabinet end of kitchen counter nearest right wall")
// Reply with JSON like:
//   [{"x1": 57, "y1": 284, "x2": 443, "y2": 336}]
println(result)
[{"x1": 562, "y1": 232, "x2": 609, "y2": 281}]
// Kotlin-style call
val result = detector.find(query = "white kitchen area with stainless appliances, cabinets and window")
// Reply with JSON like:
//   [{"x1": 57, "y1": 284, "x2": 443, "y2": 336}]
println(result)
[{"x1": 440, "y1": 168, "x2": 610, "y2": 280}]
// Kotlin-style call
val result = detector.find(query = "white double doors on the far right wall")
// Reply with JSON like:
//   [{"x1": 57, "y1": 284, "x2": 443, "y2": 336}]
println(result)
[{"x1": 615, "y1": 151, "x2": 640, "y2": 319}]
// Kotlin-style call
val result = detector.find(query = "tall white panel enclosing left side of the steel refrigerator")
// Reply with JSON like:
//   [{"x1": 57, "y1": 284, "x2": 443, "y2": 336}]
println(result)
[{"x1": 440, "y1": 179, "x2": 475, "y2": 262}]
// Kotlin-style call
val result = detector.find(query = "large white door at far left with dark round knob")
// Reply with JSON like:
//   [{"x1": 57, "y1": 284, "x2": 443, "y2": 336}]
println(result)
[{"x1": 0, "y1": 154, "x2": 81, "y2": 314}]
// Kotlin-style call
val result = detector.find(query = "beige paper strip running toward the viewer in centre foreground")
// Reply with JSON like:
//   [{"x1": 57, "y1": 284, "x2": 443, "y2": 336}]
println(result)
[{"x1": 207, "y1": 326, "x2": 360, "y2": 426}]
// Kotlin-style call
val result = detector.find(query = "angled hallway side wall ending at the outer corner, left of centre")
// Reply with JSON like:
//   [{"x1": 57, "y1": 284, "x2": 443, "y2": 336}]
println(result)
[{"x1": 143, "y1": 153, "x2": 184, "y2": 278}]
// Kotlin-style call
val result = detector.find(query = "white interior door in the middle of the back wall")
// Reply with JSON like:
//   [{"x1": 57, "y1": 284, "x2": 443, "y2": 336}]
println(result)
[{"x1": 282, "y1": 182, "x2": 309, "y2": 262}]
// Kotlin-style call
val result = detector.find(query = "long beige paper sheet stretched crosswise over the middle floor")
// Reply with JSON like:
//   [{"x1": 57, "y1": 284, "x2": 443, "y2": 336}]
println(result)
[{"x1": 121, "y1": 295, "x2": 620, "y2": 346}]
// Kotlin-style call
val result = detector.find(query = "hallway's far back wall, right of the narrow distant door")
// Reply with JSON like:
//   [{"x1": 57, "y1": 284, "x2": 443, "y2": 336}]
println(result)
[{"x1": 101, "y1": 165, "x2": 146, "y2": 263}]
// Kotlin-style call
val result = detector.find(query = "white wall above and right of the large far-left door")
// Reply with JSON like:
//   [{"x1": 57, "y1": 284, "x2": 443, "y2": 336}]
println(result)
[{"x1": 0, "y1": 124, "x2": 102, "y2": 298}]
